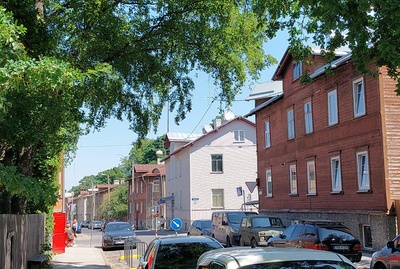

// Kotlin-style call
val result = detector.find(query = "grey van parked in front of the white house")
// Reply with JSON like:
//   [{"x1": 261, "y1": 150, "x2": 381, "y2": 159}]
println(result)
[{"x1": 211, "y1": 211, "x2": 258, "y2": 247}]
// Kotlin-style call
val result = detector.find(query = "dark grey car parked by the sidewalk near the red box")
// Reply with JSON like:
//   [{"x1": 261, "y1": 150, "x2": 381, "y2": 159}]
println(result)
[{"x1": 101, "y1": 221, "x2": 137, "y2": 250}]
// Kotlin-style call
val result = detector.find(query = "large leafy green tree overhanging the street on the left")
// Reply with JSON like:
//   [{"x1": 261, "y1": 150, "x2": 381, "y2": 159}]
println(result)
[{"x1": 0, "y1": 0, "x2": 273, "y2": 213}]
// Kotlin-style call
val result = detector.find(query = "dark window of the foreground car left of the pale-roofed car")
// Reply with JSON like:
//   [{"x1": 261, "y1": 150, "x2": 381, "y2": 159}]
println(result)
[{"x1": 154, "y1": 242, "x2": 221, "y2": 269}]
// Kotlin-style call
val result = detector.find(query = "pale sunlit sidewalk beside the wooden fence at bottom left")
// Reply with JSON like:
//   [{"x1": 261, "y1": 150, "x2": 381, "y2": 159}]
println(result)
[{"x1": 51, "y1": 247, "x2": 110, "y2": 269}]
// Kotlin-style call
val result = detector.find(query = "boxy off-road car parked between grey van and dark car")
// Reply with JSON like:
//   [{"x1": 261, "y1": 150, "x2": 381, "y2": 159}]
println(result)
[{"x1": 239, "y1": 215, "x2": 286, "y2": 247}]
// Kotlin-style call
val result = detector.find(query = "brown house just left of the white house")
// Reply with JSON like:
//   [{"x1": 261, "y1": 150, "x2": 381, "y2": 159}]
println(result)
[{"x1": 128, "y1": 164, "x2": 165, "y2": 230}]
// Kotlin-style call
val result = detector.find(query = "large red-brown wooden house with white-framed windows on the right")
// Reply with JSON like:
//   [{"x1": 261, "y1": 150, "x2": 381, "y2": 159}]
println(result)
[{"x1": 246, "y1": 47, "x2": 400, "y2": 250}]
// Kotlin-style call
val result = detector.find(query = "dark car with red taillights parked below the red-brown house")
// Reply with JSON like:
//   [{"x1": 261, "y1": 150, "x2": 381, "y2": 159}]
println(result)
[{"x1": 267, "y1": 220, "x2": 362, "y2": 262}]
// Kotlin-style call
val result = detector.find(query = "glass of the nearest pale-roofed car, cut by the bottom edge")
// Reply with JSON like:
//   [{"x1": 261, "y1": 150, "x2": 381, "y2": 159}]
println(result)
[{"x1": 239, "y1": 260, "x2": 356, "y2": 269}]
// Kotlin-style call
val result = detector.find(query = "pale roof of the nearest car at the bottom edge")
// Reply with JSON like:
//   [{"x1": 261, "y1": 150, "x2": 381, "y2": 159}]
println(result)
[{"x1": 198, "y1": 247, "x2": 354, "y2": 267}]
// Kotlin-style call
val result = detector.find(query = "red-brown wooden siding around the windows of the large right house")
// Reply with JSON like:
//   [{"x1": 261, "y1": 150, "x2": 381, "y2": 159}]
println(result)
[{"x1": 256, "y1": 60, "x2": 388, "y2": 212}]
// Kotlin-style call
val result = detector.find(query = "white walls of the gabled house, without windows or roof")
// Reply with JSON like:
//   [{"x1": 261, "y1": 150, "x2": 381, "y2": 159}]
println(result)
[{"x1": 165, "y1": 120, "x2": 258, "y2": 229}]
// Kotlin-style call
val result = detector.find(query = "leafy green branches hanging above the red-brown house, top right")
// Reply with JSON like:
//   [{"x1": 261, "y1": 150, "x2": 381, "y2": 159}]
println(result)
[{"x1": 252, "y1": 0, "x2": 400, "y2": 90}]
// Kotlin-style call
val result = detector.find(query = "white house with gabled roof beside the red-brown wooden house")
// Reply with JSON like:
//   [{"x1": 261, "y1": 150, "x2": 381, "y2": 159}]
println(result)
[{"x1": 163, "y1": 115, "x2": 258, "y2": 230}]
